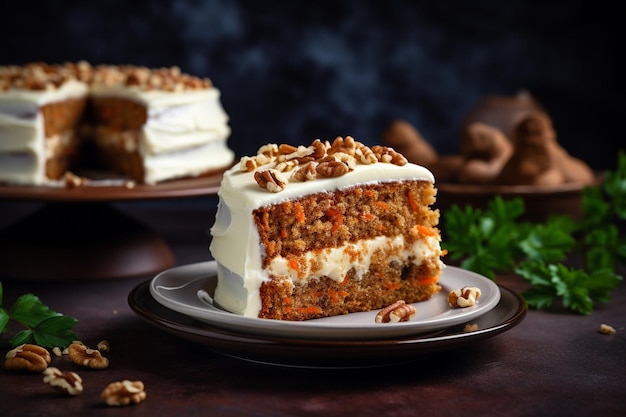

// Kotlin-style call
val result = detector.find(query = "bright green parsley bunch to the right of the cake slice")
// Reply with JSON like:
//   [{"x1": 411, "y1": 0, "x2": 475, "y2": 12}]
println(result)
[{"x1": 442, "y1": 151, "x2": 626, "y2": 314}]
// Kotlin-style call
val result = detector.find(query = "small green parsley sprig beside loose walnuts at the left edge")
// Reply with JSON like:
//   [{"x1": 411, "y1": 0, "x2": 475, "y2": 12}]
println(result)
[{"x1": 0, "y1": 283, "x2": 78, "y2": 349}]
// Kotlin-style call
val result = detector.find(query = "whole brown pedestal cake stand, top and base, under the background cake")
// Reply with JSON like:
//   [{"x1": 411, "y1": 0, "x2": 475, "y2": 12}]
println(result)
[{"x1": 0, "y1": 172, "x2": 223, "y2": 280}]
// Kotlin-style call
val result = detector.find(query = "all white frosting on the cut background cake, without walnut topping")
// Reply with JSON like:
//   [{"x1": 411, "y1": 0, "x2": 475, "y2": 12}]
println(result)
[{"x1": 0, "y1": 81, "x2": 234, "y2": 184}]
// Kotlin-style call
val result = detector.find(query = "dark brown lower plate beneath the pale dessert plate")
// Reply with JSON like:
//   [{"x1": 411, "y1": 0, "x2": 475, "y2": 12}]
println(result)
[{"x1": 128, "y1": 281, "x2": 527, "y2": 369}]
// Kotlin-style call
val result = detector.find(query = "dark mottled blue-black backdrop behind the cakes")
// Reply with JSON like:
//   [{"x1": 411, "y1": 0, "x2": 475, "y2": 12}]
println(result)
[{"x1": 0, "y1": 0, "x2": 626, "y2": 169}]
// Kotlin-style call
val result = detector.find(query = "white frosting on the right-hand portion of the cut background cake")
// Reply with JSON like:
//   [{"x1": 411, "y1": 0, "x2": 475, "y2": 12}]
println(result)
[{"x1": 91, "y1": 86, "x2": 235, "y2": 184}]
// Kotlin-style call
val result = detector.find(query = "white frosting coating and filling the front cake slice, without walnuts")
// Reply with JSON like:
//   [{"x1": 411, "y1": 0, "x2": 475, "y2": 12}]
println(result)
[{"x1": 210, "y1": 159, "x2": 440, "y2": 317}]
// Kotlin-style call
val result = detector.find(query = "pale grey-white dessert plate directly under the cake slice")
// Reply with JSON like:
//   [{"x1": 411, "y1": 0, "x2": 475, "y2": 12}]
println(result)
[{"x1": 149, "y1": 261, "x2": 500, "y2": 340}]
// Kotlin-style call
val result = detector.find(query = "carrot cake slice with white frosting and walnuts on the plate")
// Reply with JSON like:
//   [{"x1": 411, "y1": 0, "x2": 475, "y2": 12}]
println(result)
[{"x1": 210, "y1": 136, "x2": 444, "y2": 320}]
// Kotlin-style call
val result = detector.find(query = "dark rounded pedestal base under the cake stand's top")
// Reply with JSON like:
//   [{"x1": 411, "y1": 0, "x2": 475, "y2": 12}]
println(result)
[{"x1": 0, "y1": 202, "x2": 174, "y2": 280}]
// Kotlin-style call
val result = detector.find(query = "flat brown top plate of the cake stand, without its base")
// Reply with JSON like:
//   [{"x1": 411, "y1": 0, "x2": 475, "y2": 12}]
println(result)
[{"x1": 0, "y1": 170, "x2": 225, "y2": 202}]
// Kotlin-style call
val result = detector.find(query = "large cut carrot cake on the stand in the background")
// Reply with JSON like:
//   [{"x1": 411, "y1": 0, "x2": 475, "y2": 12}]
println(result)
[{"x1": 0, "y1": 62, "x2": 234, "y2": 185}]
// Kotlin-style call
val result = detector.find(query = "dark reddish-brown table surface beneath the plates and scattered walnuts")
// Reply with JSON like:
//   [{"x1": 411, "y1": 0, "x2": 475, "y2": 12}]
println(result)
[{"x1": 0, "y1": 197, "x2": 626, "y2": 417}]
